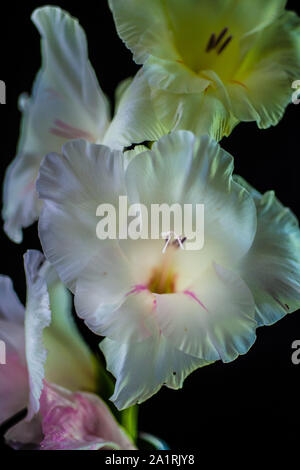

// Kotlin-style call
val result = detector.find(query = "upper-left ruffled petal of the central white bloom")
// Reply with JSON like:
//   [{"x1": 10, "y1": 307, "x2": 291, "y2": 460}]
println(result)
[{"x1": 37, "y1": 141, "x2": 126, "y2": 290}]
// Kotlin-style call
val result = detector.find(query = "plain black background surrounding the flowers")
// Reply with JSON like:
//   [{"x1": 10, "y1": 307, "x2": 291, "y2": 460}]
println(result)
[{"x1": 0, "y1": 0, "x2": 300, "y2": 452}]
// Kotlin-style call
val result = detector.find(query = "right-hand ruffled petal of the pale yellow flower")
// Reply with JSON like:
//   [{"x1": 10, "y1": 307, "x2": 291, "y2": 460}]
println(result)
[{"x1": 226, "y1": 12, "x2": 300, "y2": 128}]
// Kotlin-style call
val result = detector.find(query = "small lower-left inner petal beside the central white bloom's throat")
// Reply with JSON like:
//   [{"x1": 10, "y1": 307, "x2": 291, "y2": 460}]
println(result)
[{"x1": 75, "y1": 253, "x2": 154, "y2": 342}]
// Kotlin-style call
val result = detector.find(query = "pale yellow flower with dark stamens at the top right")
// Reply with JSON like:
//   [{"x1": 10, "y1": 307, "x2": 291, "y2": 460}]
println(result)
[{"x1": 109, "y1": 0, "x2": 300, "y2": 140}]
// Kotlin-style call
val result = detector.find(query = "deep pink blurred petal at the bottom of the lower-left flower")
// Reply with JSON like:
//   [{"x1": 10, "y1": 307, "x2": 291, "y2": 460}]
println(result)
[{"x1": 40, "y1": 383, "x2": 134, "y2": 450}]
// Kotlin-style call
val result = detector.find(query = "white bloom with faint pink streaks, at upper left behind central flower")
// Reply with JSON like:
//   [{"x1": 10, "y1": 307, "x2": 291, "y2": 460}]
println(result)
[{"x1": 3, "y1": 7, "x2": 155, "y2": 243}]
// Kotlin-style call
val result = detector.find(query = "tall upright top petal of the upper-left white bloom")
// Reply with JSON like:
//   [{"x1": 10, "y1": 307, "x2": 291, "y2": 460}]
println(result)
[{"x1": 32, "y1": 7, "x2": 109, "y2": 136}]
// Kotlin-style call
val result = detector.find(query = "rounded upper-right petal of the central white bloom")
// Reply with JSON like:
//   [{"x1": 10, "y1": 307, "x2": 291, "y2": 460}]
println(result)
[{"x1": 126, "y1": 131, "x2": 256, "y2": 262}]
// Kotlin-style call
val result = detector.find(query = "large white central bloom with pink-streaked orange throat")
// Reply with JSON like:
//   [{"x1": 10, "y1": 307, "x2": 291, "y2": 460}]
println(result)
[{"x1": 37, "y1": 131, "x2": 300, "y2": 408}]
